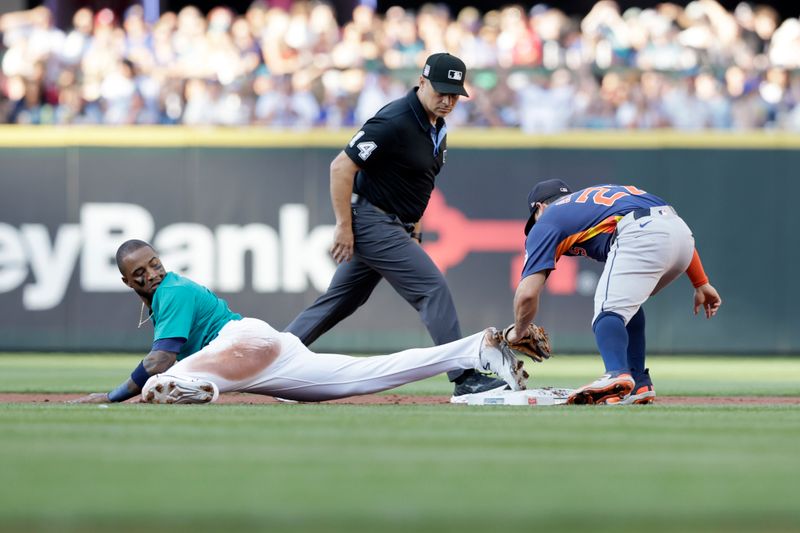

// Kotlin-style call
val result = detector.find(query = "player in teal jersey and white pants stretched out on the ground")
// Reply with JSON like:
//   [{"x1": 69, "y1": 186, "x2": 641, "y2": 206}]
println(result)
[{"x1": 74, "y1": 240, "x2": 549, "y2": 403}]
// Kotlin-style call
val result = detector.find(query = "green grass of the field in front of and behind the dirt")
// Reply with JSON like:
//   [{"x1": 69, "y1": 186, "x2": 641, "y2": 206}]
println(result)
[{"x1": 0, "y1": 354, "x2": 800, "y2": 532}]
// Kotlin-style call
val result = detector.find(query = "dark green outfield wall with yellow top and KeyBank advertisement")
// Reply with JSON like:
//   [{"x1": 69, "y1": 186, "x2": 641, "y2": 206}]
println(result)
[{"x1": 0, "y1": 127, "x2": 800, "y2": 353}]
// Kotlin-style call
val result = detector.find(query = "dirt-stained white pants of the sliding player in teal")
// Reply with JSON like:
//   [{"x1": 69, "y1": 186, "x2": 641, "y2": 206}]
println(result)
[{"x1": 158, "y1": 318, "x2": 484, "y2": 401}]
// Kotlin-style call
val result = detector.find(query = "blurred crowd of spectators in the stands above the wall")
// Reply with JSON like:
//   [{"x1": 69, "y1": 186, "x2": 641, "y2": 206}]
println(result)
[{"x1": 0, "y1": 0, "x2": 800, "y2": 133}]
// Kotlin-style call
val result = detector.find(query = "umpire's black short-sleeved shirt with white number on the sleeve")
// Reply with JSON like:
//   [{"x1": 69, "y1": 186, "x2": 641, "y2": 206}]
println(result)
[{"x1": 344, "y1": 87, "x2": 447, "y2": 223}]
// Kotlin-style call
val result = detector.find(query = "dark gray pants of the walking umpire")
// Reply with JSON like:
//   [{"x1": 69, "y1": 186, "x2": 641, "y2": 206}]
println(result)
[{"x1": 286, "y1": 200, "x2": 462, "y2": 381}]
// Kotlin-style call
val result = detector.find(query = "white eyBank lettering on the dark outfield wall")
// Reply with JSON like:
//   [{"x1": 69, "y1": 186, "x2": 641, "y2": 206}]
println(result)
[{"x1": 0, "y1": 203, "x2": 336, "y2": 311}]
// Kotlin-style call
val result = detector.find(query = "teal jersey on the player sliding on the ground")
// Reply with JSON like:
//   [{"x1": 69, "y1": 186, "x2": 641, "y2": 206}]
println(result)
[{"x1": 151, "y1": 272, "x2": 242, "y2": 361}]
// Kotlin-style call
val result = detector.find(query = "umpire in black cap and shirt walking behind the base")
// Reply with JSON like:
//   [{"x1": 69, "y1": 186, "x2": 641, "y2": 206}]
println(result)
[{"x1": 286, "y1": 53, "x2": 505, "y2": 396}]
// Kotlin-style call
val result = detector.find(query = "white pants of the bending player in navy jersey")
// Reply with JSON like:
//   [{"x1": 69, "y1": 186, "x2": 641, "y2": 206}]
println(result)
[{"x1": 592, "y1": 206, "x2": 694, "y2": 324}]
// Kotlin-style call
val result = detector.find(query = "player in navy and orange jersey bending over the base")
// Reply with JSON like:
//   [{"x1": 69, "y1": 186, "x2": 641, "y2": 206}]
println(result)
[{"x1": 504, "y1": 179, "x2": 722, "y2": 404}]
